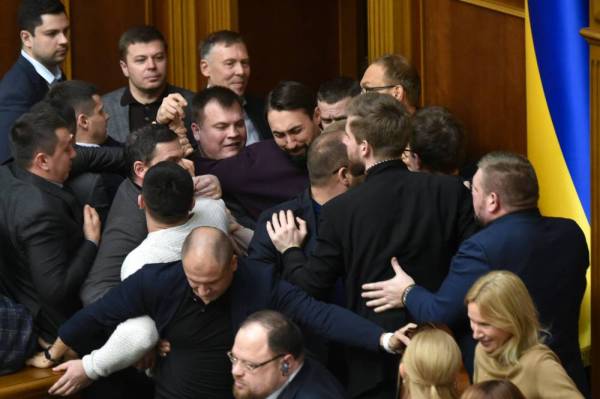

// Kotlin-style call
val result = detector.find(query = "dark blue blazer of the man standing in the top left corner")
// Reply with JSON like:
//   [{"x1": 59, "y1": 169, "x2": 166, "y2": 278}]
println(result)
[{"x1": 0, "y1": 55, "x2": 48, "y2": 163}]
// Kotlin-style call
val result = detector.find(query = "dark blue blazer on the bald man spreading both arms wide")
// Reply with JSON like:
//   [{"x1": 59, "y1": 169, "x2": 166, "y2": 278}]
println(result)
[{"x1": 59, "y1": 261, "x2": 384, "y2": 353}]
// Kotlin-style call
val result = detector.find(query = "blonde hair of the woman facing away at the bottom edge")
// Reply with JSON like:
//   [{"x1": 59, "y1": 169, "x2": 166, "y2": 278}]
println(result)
[{"x1": 402, "y1": 328, "x2": 462, "y2": 399}]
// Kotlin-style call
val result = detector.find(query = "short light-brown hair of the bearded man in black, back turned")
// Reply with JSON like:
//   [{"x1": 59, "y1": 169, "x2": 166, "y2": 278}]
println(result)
[{"x1": 348, "y1": 93, "x2": 410, "y2": 158}]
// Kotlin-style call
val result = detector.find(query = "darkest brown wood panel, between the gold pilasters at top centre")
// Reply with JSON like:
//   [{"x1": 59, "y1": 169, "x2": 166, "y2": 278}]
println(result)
[{"x1": 239, "y1": 0, "x2": 339, "y2": 95}]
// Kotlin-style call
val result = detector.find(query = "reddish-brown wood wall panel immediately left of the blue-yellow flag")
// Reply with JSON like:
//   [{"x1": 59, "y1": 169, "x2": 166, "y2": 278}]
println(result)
[{"x1": 421, "y1": 0, "x2": 527, "y2": 160}]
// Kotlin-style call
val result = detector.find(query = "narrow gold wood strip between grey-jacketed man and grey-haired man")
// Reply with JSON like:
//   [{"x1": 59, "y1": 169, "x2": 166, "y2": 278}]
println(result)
[{"x1": 167, "y1": 0, "x2": 198, "y2": 91}]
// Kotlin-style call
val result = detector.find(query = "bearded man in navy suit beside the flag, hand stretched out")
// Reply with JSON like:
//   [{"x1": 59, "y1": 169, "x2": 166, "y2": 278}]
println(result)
[{"x1": 364, "y1": 153, "x2": 589, "y2": 394}]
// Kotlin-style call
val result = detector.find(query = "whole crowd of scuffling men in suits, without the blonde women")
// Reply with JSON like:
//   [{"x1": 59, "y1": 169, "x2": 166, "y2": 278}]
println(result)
[{"x1": 0, "y1": 0, "x2": 589, "y2": 398}]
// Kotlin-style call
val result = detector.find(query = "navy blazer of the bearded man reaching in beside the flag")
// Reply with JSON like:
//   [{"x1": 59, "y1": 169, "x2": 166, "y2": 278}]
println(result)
[{"x1": 406, "y1": 209, "x2": 589, "y2": 392}]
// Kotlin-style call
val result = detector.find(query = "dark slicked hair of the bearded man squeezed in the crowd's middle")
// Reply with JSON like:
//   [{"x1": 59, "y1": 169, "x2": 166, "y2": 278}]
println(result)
[{"x1": 266, "y1": 80, "x2": 317, "y2": 118}]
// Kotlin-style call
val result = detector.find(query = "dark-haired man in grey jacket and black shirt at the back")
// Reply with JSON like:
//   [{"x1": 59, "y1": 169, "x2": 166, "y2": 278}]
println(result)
[{"x1": 102, "y1": 26, "x2": 196, "y2": 147}]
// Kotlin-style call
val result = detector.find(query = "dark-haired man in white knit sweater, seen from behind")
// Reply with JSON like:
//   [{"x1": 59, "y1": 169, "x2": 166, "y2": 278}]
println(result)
[{"x1": 51, "y1": 161, "x2": 228, "y2": 391}]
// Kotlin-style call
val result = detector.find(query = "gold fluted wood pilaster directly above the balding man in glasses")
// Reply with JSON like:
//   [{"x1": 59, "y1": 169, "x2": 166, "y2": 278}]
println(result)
[{"x1": 367, "y1": 0, "x2": 412, "y2": 62}]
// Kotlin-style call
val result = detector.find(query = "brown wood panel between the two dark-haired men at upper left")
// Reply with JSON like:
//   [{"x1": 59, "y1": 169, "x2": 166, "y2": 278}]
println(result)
[{"x1": 71, "y1": 0, "x2": 145, "y2": 93}]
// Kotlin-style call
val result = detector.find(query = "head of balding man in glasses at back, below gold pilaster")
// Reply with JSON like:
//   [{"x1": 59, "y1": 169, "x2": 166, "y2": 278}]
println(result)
[{"x1": 360, "y1": 54, "x2": 421, "y2": 114}]
